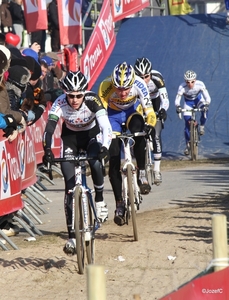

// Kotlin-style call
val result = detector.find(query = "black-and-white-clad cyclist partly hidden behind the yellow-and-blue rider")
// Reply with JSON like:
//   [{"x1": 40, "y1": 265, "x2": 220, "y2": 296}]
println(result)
[{"x1": 134, "y1": 57, "x2": 169, "y2": 185}]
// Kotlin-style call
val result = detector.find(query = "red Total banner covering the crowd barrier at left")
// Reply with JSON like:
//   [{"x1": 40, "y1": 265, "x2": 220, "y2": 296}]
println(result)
[{"x1": 0, "y1": 102, "x2": 62, "y2": 216}]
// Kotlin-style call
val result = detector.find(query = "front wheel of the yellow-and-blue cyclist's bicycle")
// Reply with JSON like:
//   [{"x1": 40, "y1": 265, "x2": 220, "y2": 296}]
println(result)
[{"x1": 127, "y1": 165, "x2": 138, "y2": 241}]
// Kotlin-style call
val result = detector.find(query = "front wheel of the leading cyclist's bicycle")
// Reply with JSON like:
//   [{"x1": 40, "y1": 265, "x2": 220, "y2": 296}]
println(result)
[{"x1": 74, "y1": 187, "x2": 85, "y2": 274}]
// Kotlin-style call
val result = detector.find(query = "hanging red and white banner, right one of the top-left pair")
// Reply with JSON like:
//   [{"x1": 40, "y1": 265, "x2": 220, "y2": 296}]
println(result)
[{"x1": 57, "y1": 0, "x2": 82, "y2": 45}]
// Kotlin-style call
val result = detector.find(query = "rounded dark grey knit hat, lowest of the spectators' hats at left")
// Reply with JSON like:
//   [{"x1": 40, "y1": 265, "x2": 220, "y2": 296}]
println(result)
[{"x1": 7, "y1": 66, "x2": 31, "y2": 89}]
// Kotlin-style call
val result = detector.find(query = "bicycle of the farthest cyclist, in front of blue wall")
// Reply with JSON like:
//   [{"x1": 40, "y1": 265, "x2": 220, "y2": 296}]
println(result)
[{"x1": 179, "y1": 107, "x2": 206, "y2": 161}]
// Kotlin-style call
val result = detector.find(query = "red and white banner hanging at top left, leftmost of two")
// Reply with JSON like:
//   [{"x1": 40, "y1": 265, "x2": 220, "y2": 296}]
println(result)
[{"x1": 23, "y1": 0, "x2": 48, "y2": 32}]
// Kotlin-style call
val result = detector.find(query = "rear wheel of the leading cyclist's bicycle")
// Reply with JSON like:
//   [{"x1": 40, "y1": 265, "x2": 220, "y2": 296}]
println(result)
[{"x1": 85, "y1": 193, "x2": 95, "y2": 264}]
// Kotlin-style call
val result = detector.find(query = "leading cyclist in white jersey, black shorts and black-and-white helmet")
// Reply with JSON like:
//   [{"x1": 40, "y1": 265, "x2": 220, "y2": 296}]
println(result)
[{"x1": 43, "y1": 71, "x2": 112, "y2": 254}]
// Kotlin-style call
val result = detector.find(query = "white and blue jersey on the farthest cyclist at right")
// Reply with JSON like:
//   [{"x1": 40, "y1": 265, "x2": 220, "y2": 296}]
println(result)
[{"x1": 175, "y1": 80, "x2": 211, "y2": 106}]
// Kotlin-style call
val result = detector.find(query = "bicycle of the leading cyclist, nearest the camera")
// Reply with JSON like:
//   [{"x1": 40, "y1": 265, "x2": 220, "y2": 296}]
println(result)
[{"x1": 50, "y1": 151, "x2": 100, "y2": 274}]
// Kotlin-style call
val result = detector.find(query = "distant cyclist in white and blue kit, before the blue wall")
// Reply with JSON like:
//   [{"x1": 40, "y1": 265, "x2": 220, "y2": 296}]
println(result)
[{"x1": 175, "y1": 70, "x2": 211, "y2": 155}]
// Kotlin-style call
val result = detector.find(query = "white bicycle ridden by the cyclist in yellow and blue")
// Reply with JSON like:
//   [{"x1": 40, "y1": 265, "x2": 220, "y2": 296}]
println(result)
[{"x1": 113, "y1": 124, "x2": 145, "y2": 241}]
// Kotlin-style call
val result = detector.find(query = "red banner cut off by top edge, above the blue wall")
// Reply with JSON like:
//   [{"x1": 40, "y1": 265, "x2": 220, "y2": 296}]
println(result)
[{"x1": 111, "y1": 0, "x2": 150, "y2": 22}]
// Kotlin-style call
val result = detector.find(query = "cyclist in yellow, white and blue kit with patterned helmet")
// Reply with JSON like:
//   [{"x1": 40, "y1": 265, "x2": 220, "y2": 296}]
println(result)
[{"x1": 98, "y1": 62, "x2": 156, "y2": 226}]
